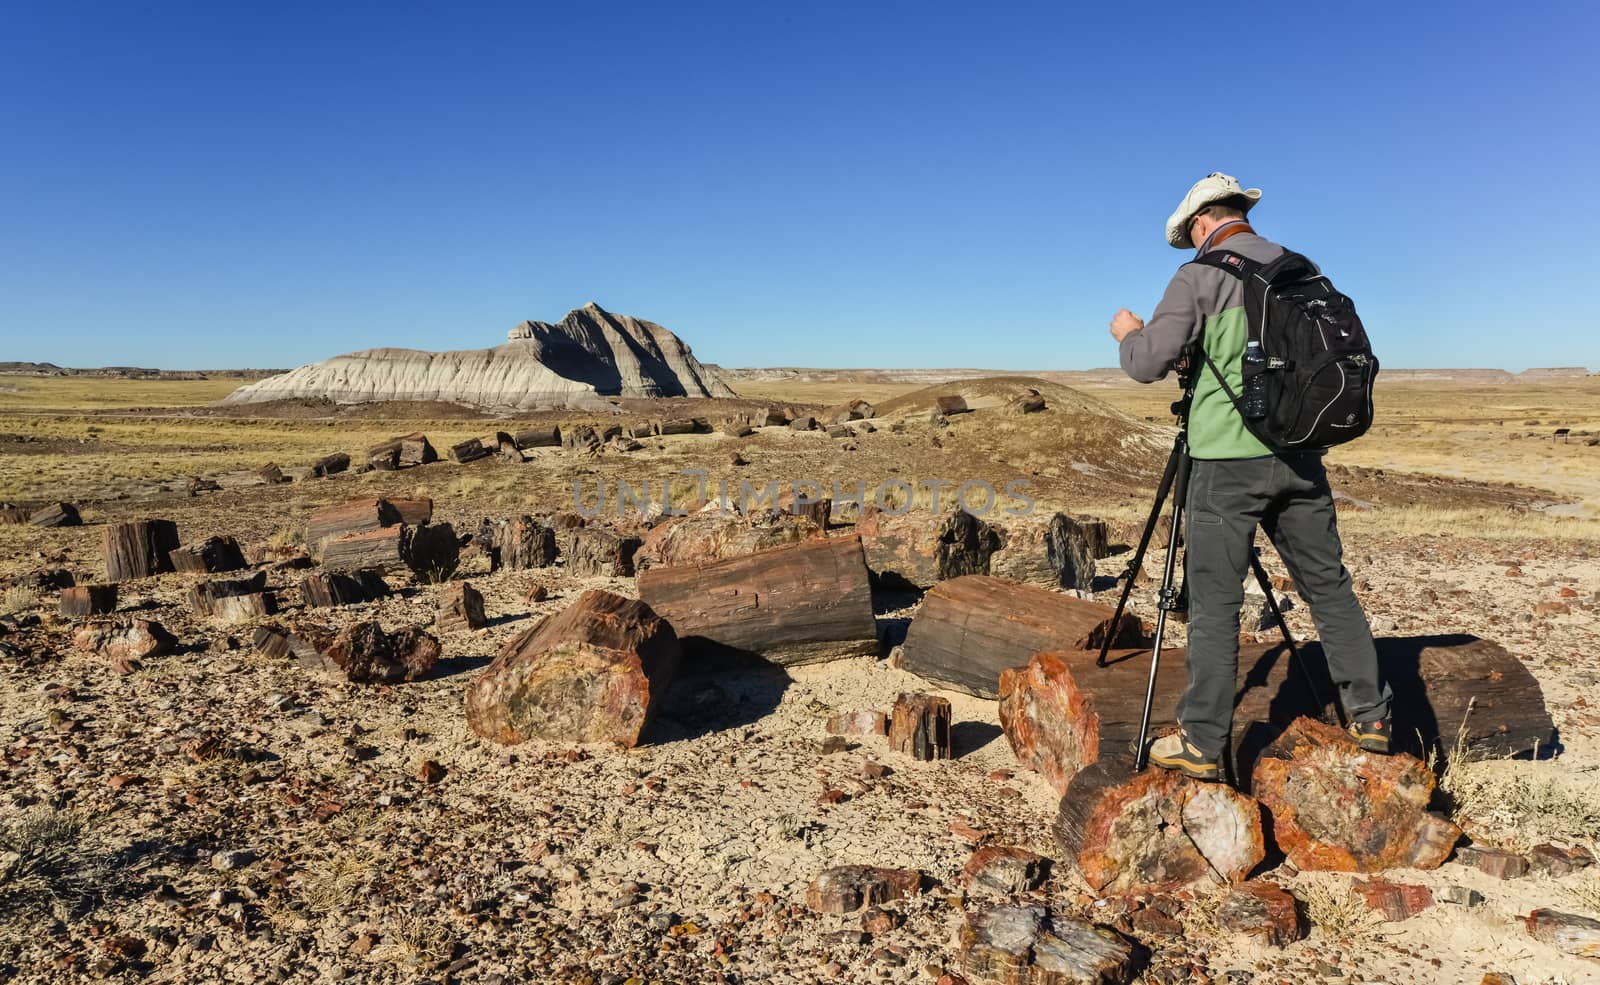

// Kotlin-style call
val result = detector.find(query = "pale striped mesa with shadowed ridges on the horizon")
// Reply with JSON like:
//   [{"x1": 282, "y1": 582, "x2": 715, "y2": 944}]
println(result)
[{"x1": 222, "y1": 302, "x2": 734, "y2": 409}]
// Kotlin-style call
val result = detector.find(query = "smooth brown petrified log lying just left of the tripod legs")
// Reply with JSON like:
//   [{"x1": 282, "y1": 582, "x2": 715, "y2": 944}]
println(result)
[{"x1": 901, "y1": 574, "x2": 1152, "y2": 700}]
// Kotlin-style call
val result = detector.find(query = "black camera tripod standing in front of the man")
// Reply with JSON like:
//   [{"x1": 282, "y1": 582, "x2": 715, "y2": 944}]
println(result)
[{"x1": 1094, "y1": 368, "x2": 1344, "y2": 772}]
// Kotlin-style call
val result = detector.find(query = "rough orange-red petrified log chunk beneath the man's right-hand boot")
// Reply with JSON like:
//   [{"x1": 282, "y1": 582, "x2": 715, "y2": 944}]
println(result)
[{"x1": 1253, "y1": 718, "x2": 1461, "y2": 871}]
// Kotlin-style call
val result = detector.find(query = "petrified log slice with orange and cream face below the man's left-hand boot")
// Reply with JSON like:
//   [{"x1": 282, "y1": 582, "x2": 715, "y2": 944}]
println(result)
[{"x1": 1053, "y1": 763, "x2": 1266, "y2": 894}]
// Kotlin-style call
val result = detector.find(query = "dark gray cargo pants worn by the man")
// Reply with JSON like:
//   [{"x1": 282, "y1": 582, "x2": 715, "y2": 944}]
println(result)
[{"x1": 1178, "y1": 454, "x2": 1390, "y2": 758}]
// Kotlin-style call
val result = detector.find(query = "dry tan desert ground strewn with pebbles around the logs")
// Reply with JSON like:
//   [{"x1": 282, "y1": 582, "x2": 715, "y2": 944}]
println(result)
[{"x1": 0, "y1": 371, "x2": 1600, "y2": 985}]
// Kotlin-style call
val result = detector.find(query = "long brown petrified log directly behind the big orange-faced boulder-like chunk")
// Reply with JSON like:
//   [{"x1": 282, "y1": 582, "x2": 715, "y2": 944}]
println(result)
[{"x1": 638, "y1": 537, "x2": 878, "y2": 665}]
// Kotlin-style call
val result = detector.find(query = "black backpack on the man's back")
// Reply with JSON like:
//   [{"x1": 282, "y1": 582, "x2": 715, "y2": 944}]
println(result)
[{"x1": 1194, "y1": 249, "x2": 1378, "y2": 453}]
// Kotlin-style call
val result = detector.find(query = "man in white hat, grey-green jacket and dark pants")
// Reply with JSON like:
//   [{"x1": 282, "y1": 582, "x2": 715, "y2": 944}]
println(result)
[{"x1": 1110, "y1": 173, "x2": 1390, "y2": 780}]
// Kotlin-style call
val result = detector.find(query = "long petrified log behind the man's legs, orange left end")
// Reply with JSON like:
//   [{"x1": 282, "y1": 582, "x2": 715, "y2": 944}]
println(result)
[{"x1": 1017, "y1": 636, "x2": 1555, "y2": 790}]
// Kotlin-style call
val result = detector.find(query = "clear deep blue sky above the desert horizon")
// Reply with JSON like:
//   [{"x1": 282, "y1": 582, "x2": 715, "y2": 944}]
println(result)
[{"x1": 0, "y1": 0, "x2": 1600, "y2": 369}]
